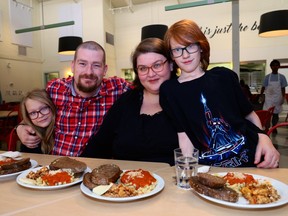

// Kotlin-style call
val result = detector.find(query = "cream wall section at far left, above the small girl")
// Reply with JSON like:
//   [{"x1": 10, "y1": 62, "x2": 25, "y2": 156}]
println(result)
[{"x1": 0, "y1": 0, "x2": 43, "y2": 102}]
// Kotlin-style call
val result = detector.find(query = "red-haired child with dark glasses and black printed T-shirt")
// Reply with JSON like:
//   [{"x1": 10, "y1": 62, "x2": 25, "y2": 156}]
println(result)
[{"x1": 160, "y1": 20, "x2": 280, "y2": 168}]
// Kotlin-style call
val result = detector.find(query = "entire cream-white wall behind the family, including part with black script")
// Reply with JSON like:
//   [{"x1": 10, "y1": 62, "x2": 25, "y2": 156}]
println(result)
[{"x1": 0, "y1": 0, "x2": 288, "y2": 101}]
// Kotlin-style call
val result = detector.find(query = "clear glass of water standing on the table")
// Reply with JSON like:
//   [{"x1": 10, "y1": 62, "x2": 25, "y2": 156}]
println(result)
[{"x1": 174, "y1": 148, "x2": 199, "y2": 190}]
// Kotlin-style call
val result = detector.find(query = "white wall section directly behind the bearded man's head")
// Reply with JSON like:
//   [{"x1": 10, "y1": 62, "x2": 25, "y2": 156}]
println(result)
[{"x1": 43, "y1": 0, "x2": 116, "y2": 77}]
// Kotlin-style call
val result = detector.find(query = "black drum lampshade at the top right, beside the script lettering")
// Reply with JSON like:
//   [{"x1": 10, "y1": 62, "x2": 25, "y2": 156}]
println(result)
[{"x1": 259, "y1": 10, "x2": 288, "y2": 37}]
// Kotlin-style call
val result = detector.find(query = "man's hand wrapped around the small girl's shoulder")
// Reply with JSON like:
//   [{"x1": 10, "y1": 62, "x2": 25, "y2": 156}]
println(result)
[{"x1": 16, "y1": 124, "x2": 41, "y2": 148}]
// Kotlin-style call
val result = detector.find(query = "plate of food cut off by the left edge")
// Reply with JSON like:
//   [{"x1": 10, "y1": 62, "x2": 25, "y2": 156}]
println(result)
[{"x1": 0, "y1": 152, "x2": 38, "y2": 180}]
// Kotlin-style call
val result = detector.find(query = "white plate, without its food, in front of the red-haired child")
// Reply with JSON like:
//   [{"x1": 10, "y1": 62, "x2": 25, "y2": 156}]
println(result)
[{"x1": 193, "y1": 172, "x2": 288, "y2": 209}]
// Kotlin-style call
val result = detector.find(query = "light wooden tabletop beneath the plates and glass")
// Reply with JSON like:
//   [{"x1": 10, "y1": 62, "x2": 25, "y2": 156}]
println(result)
[{"x1": 0, "y1": 154, "x2": 288, "y2": 216}]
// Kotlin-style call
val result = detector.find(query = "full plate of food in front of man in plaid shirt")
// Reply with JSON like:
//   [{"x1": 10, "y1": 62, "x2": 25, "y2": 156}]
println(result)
[{"x1": 16, "y1": 157, "x2": 91, "y2": 190}]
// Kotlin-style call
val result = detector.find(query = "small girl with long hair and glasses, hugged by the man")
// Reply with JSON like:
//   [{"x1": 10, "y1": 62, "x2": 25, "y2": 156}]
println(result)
[{"x1": 20, "y1": 89, "x2": 56, "y2": 154}]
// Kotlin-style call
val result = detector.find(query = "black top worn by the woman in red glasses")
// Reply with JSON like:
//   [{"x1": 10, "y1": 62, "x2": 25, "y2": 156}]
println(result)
[{"x1": 81, "y1": 90, "x2": 178, "y2": 165}]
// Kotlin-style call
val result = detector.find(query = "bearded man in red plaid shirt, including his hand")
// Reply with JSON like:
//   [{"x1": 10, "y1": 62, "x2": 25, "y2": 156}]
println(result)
[{"x1": 17, "y1": 41, "x2": 130, "y2": 157}]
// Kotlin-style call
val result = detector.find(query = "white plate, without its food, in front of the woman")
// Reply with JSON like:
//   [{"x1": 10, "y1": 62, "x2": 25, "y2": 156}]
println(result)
[{"x1": 80, "y1": 173, "x2": 165, "y2": 202}]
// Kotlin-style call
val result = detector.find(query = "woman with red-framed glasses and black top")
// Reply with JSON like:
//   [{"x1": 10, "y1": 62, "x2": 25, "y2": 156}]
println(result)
[{"x1": 82, "y1": 38, "x2": 178, "y2": 165}]
